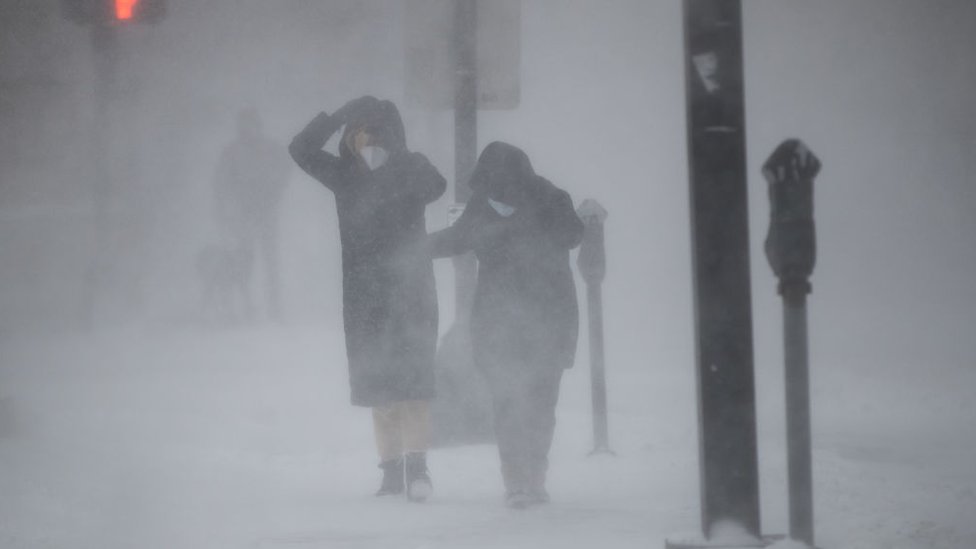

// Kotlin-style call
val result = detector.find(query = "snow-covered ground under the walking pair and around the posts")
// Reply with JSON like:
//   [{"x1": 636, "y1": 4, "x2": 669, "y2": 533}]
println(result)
[{"x1": 0, "y1": 326, "x2": 976, "y2": 549}]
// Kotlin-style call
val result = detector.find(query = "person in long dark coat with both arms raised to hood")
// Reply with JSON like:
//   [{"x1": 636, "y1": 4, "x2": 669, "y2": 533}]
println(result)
[{"x1": 289, "y1": 96, "x2": 447, "y2": 501}]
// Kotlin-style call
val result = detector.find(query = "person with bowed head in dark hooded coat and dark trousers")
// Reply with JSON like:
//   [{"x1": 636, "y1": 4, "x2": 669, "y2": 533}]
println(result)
[{"x1": 431, "y1": 142, "x2": 583, "y2": 508}]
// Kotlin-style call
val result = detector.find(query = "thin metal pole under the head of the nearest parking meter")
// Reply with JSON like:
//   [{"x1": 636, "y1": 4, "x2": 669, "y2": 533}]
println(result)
[{"x1": 783, "y1": 291, "x2": 813, "y2": 547}]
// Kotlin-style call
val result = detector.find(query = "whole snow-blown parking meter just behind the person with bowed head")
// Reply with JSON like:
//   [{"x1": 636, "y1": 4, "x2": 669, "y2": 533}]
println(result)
[{"x1": 576, "y1": 199, "x2": 613, "y2": 454}]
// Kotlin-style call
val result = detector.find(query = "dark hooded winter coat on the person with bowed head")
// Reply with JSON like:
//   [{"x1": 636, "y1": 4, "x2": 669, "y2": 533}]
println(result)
[{"x1": 431, "y1": 142, "x2": 583, "y2": 368}]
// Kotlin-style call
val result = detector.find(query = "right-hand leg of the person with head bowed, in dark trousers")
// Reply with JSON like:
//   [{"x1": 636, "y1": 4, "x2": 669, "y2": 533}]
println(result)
[{"x1": 526, "y1": 368, "x2": 563, "y2": 503}]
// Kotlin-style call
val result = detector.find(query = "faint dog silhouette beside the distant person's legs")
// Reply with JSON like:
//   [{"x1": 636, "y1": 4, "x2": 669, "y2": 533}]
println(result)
[{"x1": 196, "y1": 244, "x2": 254, "y2": 323}]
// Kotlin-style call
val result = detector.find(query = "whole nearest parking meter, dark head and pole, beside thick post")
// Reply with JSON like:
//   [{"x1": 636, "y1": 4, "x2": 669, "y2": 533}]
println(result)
[{"x1": 763, "y1": 139, "x2": 820, "y2": 546}]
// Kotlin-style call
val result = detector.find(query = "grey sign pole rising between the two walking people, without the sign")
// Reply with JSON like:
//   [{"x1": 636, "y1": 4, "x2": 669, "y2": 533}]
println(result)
[{"x1": 454, "y1": 0, "x2": 478, "y2": 322}]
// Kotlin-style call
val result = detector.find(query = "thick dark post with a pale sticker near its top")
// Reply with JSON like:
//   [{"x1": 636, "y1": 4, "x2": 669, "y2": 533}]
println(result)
[{"x1": 684, "y1": 0, "x2": 760, "y2": 540}]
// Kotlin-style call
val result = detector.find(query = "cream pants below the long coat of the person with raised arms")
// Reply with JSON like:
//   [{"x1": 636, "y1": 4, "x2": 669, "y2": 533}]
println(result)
[{"x1": 373, "y1": 400, "x2": 430, "y2": 461}]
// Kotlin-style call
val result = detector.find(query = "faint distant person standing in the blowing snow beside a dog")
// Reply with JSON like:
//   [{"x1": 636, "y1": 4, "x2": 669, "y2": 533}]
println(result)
[{"x1": 214, "y1": 109, "x2": 291, "y2": 319}]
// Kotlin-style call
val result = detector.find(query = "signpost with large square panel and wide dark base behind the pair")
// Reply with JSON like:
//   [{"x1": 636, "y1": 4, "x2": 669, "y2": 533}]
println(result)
[{"x1": 404, "y1": 0, "x2": 521, "y2": 444}]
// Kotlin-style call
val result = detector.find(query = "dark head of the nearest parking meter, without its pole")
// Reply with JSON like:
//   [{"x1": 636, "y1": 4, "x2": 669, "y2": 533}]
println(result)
[{"x1": 762, "y1": 139, "x2": 820, "y2": 297}]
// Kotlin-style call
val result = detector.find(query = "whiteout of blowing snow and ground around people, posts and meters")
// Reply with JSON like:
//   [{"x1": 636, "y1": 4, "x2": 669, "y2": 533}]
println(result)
[{"x1": 0, "y1": 0, "x2": 976, "y2": 549}]
